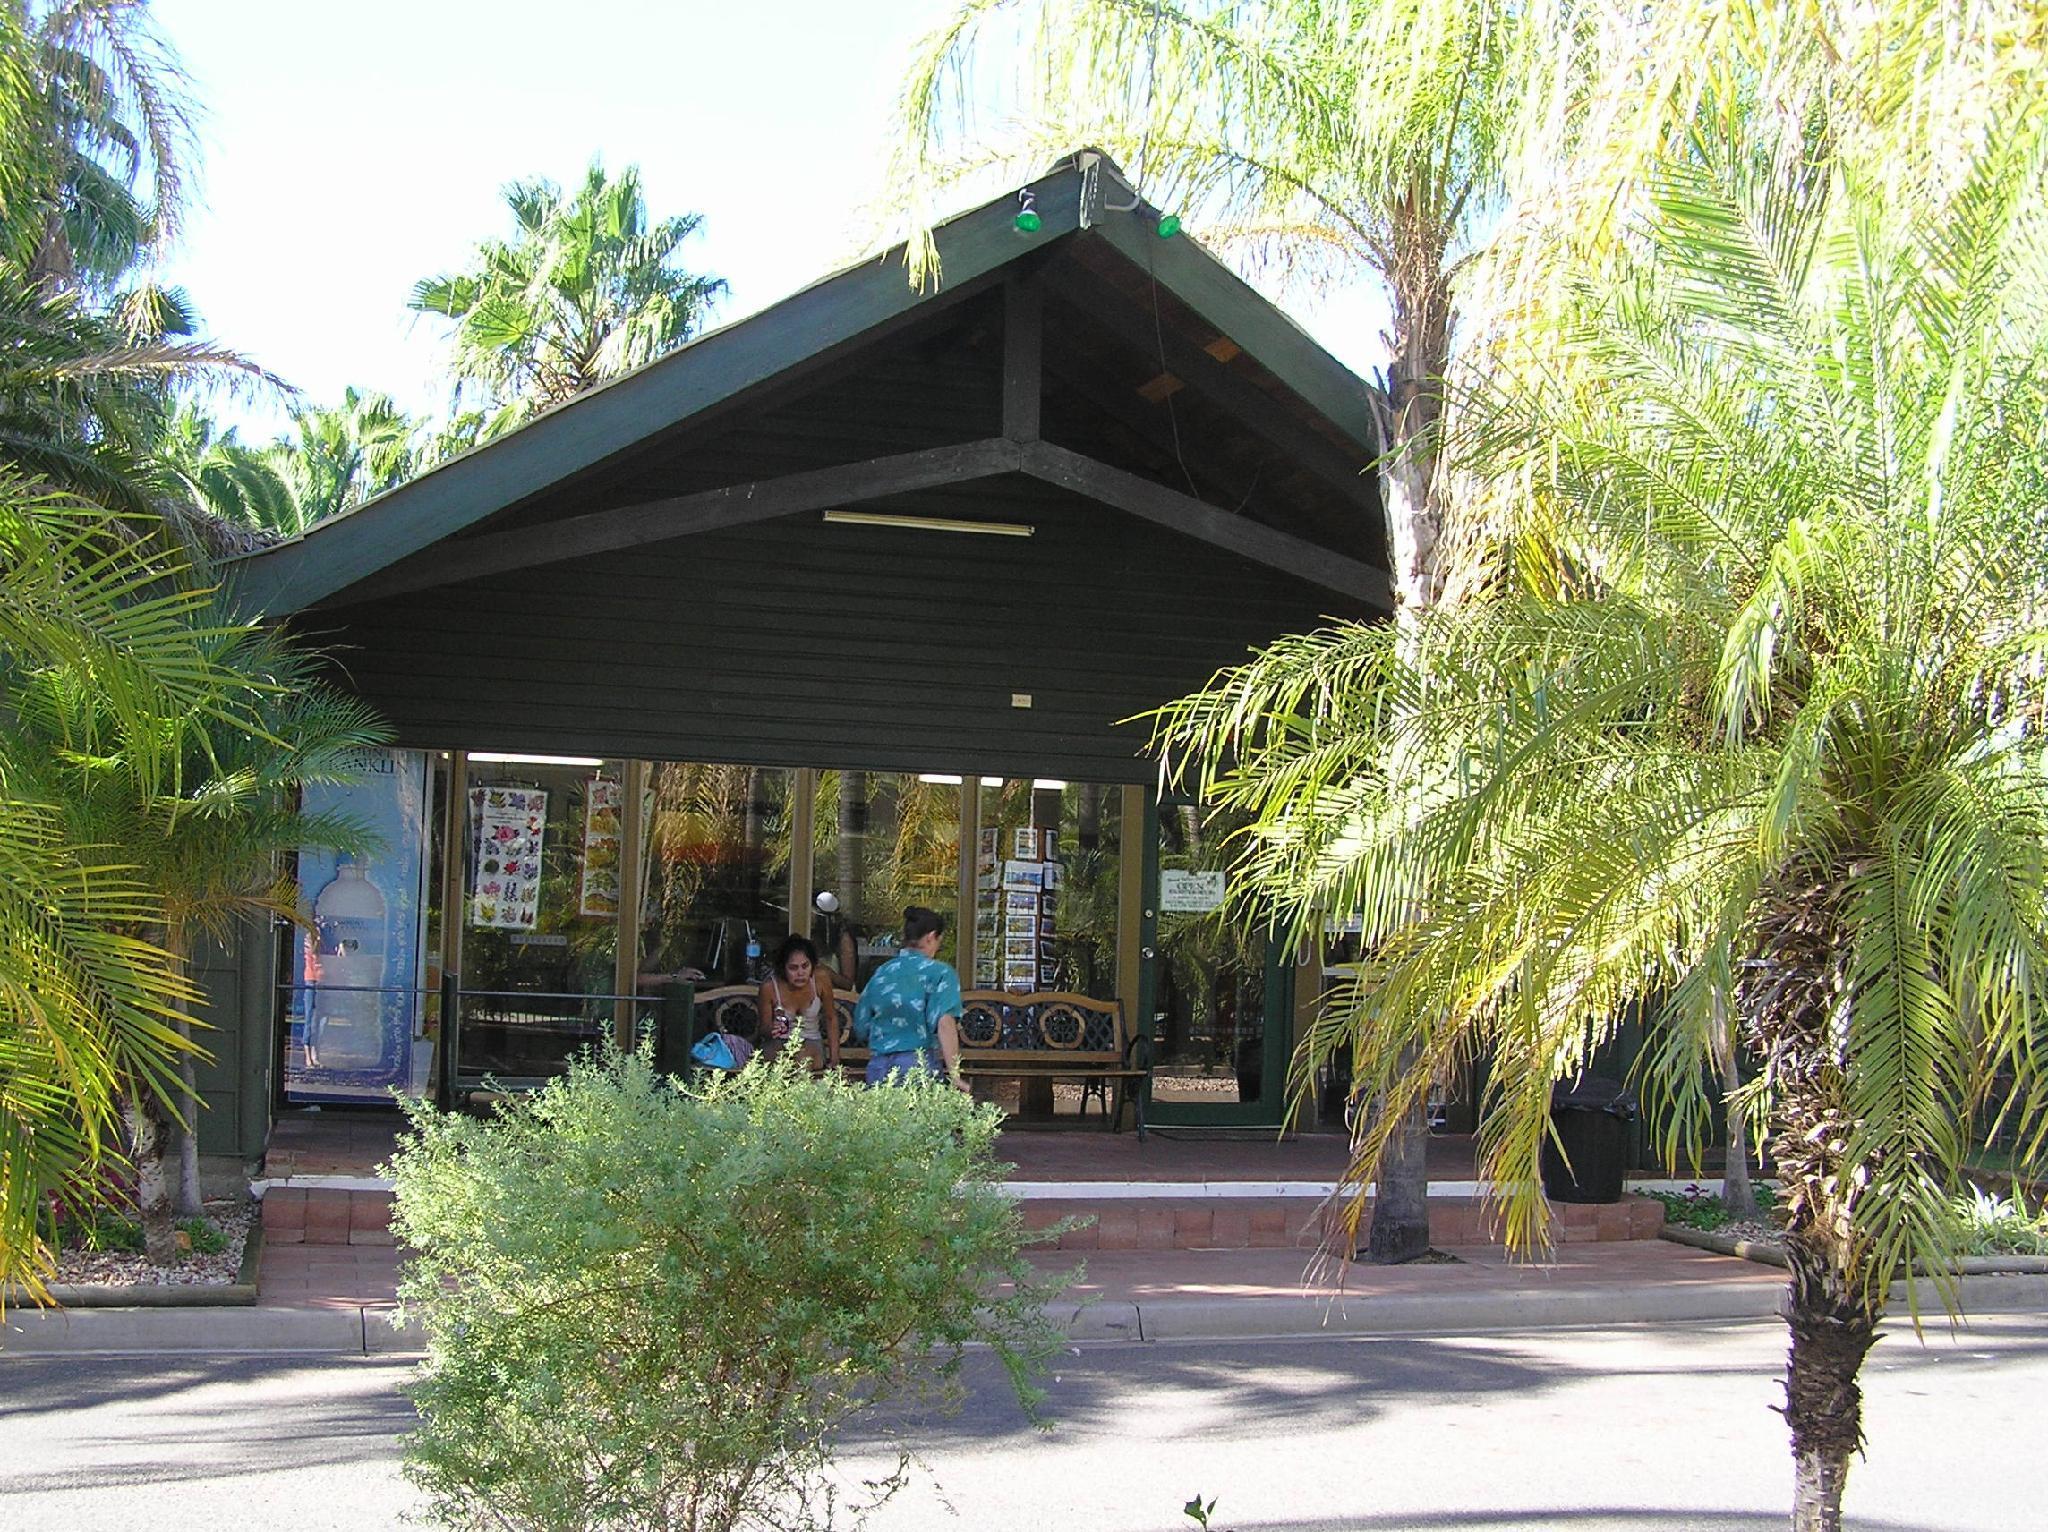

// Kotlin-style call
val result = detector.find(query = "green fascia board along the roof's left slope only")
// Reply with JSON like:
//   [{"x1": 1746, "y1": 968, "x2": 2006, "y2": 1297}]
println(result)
[{"x1": 225, "y1": 166, "x2": 1081, "y2": 616}]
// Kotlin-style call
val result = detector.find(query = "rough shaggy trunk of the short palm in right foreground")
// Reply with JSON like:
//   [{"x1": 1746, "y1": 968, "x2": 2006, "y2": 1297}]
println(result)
[{"x1": 1745, "y1": 879, "x2": 1884, "y2": 1532}]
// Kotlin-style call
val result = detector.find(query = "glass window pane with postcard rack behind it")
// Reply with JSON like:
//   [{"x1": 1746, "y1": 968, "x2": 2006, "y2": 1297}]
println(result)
[{"x1": 973, "y1": 778, "x2": 1122, "y2": 999}]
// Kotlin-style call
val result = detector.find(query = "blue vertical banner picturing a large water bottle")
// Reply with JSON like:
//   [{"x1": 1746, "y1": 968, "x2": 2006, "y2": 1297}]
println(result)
[{"x1": 285, "y1": 750, "x2": 432, "y2": 1102}]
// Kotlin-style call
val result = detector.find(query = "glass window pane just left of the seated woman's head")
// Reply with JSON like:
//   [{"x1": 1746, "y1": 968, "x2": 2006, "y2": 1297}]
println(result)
[{"x1": 639, "y1": 762, "x2": 795, "y2": 989}]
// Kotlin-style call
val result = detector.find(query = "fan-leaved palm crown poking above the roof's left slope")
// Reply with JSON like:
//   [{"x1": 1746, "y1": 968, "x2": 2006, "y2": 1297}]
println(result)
[{"x1": 412, "y1": 162, "x2": 725, "y2": 434}]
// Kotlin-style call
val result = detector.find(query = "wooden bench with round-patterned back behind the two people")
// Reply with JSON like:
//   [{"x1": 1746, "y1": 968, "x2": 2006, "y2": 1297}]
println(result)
[{"x1": 690, "y1": 985, "x2": 1151, "y2": 1139}]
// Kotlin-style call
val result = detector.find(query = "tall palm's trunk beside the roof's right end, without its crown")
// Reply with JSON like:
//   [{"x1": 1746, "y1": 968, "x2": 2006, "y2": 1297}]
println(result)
[{"x1": 1364, "y1": 186, "x2": 1452, "y2": 1266}]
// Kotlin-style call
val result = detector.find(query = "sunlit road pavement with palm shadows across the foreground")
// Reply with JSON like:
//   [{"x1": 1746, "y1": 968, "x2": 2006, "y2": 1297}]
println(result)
[{"x1": 0, "y1": 1315, "x2": 2048, "y2": 1532}]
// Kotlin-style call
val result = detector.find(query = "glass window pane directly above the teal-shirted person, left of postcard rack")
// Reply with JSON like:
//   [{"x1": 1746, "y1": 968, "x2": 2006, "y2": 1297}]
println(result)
[{"x1": 811, "y1": 770, "x2": 961, "y2": 987}]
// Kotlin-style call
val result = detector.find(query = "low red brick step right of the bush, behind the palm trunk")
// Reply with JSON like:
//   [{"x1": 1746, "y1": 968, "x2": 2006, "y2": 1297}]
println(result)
[{"x1": 1020, "y1": 1188, "x2": 1663, "y2": 1249}]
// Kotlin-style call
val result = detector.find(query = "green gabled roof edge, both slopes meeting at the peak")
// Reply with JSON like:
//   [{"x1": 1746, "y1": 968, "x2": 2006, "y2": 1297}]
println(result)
[{"x1": 225, "y1": 152, "x2": 1376, "y2": 616}]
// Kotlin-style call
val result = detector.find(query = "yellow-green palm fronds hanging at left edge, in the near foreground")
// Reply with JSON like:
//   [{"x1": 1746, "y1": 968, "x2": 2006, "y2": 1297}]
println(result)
[{"x1": 0, "y1": 479, "x2": 247, "y2": 1301}]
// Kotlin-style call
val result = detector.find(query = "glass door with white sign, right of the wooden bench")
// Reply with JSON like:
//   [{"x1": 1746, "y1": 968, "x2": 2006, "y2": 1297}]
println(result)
[{"x1": 1141, "y1": 799, "x2": 1292, "y2": 1126}]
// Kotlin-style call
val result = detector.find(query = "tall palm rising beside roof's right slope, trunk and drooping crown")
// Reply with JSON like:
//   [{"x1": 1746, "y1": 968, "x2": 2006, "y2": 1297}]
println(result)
[{"x1": 897, "y1": 0, "x2": 1605, "y2": 1262}]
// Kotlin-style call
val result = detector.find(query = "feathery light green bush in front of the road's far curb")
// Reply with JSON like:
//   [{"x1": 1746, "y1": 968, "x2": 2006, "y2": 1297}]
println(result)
[{"x1": 391, "y1": 1053, "x2": 1059, "y2": 1532}]
